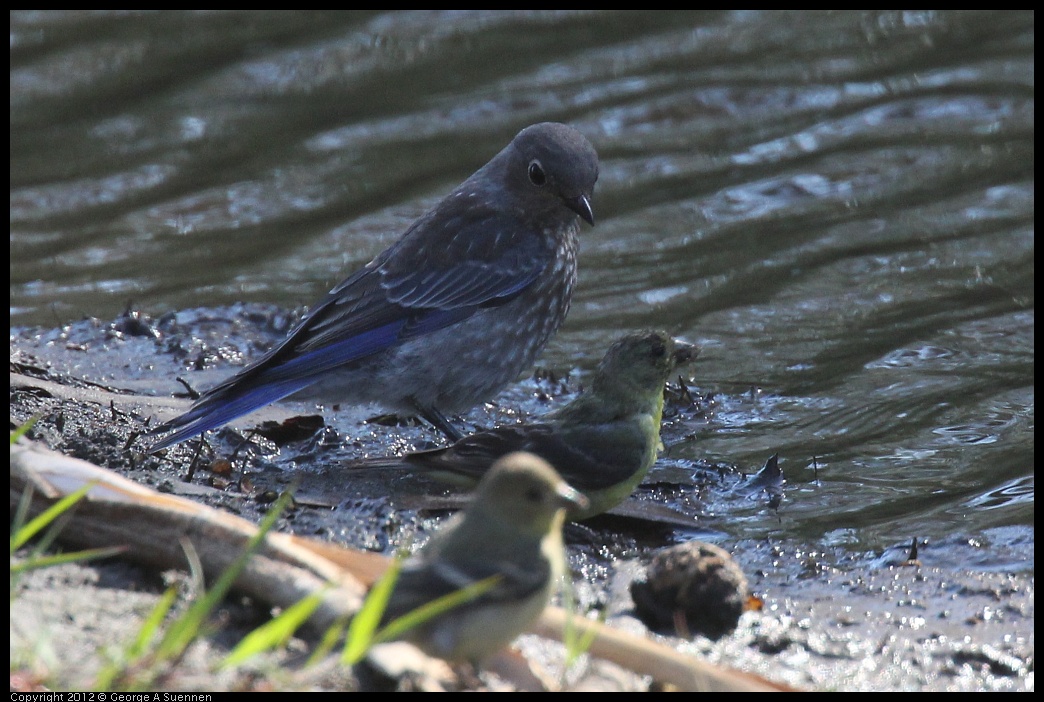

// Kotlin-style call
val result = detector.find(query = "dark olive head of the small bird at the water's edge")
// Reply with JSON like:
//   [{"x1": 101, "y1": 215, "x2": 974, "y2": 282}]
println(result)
[{"x1": 593, "y1": 331, "x2": 699, "y2": 391}]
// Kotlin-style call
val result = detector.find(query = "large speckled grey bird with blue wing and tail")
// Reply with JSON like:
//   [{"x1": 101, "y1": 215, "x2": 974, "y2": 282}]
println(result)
[{"x1": 148, "y1": 122, "x2": 598, "y2": 451}]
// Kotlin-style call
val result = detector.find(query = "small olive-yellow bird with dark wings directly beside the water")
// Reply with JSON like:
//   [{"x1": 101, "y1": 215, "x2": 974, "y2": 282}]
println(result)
[{"x1": 346, "y1": 331, "x2": 697, "y2": 520}]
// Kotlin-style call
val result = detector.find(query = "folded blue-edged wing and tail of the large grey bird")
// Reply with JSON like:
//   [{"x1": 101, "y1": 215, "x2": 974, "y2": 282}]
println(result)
[{"x1": 151, "y1": 197, "x2": 554, "y2": 450}]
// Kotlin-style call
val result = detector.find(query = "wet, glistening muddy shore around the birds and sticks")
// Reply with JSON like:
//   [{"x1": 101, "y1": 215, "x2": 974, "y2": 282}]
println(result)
[{"x1": 10, "y1": 307, "x2": 1035, "y2": 692}]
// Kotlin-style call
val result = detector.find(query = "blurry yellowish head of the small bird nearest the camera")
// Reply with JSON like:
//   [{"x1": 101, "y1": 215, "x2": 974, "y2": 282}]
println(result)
[{"x1": 474, "y1": 451, "x2": 588, "y2": 534}]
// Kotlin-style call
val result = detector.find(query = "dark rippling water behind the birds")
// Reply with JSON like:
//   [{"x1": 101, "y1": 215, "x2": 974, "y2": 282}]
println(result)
[{"x1": 10, "y1": 11, "x2": 1035, "y2": 569}]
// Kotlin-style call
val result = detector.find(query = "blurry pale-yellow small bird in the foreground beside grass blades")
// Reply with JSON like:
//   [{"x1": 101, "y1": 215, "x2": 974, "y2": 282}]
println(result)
[{"x1": 383, "y1": 452, "x2": 586, "y2": 662}]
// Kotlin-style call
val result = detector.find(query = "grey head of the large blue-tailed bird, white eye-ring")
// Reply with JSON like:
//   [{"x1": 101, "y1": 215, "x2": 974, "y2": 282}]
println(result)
[{"x1": 491, "y1": 122, "x2": 598, "y2": 225}]
